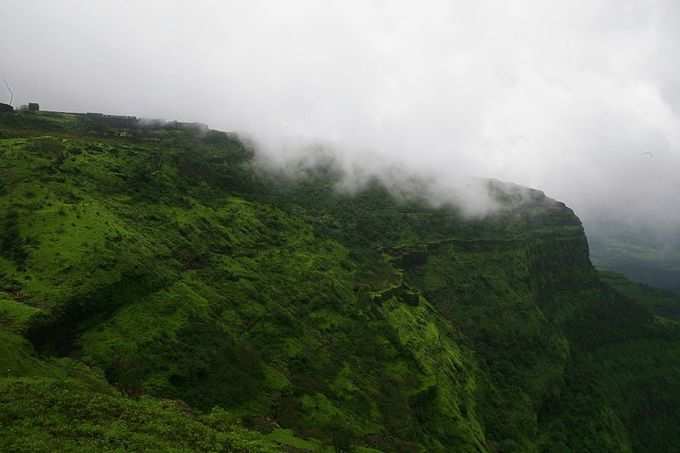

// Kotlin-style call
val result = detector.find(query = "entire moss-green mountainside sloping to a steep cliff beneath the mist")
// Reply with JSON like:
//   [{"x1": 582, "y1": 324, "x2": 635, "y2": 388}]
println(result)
[{"x1": 0, "y1": 113, "x2": 680, "y2": 452}]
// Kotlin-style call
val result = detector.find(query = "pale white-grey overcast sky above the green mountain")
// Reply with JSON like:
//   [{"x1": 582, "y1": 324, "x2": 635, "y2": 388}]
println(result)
[{"x1": 0, "y1": 0, "x2": 680, "y2": 237}]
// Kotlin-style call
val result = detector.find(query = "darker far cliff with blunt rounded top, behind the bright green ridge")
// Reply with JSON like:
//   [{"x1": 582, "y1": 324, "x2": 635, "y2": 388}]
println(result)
[{"x1": 270, "y1": 175, "x2": 632, "y2": 451}]
